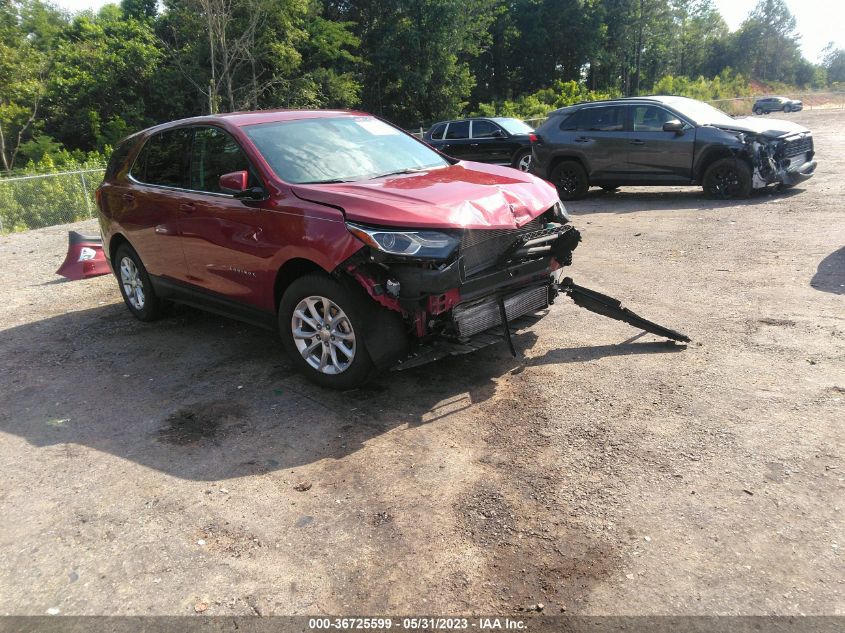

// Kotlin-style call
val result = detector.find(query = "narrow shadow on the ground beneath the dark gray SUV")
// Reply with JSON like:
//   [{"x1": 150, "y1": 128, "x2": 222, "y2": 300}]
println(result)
[{"x1": 565, "y1": 187, "x2": 804, "y2": 215}]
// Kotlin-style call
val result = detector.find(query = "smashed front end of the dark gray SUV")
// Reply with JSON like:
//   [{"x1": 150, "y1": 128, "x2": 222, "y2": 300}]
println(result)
[{"x1": 737, "y1": 132, "x2": 816, "y2": 189}]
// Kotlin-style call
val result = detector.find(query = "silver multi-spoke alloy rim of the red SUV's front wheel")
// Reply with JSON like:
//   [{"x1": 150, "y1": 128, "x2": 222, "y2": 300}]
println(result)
[{"x1": 291, "y1": 296, "x2": 356, "y2": 375}]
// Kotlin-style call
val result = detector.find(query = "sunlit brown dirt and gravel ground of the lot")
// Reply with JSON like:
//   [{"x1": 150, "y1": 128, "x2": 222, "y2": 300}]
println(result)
[{"x1": 0, "y1": 111, "x2": 845, "y2": 615}]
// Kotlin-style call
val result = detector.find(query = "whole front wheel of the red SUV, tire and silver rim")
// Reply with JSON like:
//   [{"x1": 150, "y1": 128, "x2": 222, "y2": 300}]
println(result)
[{"x1": 279, "y1": 275, "x2": 373, "y2": 389}]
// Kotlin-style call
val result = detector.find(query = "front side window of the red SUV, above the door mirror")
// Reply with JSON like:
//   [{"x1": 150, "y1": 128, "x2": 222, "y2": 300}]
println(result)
[{"x1": 190, "y1": 127, "x2": 259, "y2": 193}]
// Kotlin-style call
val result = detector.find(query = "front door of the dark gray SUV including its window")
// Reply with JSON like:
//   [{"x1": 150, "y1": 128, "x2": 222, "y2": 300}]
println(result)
[{"x1": 627, "y1": 104, "x2": 695, "y2": 184}]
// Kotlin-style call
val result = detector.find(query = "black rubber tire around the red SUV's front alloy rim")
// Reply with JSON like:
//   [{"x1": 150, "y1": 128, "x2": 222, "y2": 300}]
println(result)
[{"x1": 279, "y1": 274, "x2": 374, "y2": 389}]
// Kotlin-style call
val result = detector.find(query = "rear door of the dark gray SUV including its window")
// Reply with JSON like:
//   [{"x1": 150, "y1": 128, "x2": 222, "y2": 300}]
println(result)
[{"x1": 560, "y1": 105, "x2": 630, "y2": 182}]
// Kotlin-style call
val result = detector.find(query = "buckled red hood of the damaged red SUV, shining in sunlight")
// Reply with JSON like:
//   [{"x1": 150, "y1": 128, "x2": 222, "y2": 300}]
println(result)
[{"x1": 293, "y1": 162, "x2": 558, "y2": 229}]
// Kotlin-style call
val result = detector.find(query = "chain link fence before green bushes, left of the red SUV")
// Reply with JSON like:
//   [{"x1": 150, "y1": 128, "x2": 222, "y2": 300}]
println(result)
[{"x1": 0, "y1": 168, "x2": 105, "y2": 233}]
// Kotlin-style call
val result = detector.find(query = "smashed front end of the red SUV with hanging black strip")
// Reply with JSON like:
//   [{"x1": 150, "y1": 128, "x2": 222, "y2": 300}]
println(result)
[{"x1": 342, "y1": 202, "x2": 689, "y2": 369}]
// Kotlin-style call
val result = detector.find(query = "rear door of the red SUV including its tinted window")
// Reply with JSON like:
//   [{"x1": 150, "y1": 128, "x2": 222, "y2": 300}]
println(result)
[{"x1": 122, "y1": 128, "x2": 191, "y2": 280}]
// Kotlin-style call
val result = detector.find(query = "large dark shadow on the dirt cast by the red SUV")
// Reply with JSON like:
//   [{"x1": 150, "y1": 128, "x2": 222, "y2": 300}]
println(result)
[{"x1": 0, "y1": 303, "x2": 680, "y2": 481}]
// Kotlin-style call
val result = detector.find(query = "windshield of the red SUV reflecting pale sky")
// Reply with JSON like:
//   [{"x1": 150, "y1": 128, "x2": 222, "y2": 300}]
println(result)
[{"x1": 244, "y1": 116, "x2": 449, "y2": 184}]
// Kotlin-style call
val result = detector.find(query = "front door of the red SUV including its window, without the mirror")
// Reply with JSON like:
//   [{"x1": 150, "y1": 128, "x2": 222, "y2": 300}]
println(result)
[{"x1": 180, "y1": 126, "x2": 279, "y2": 307}]
